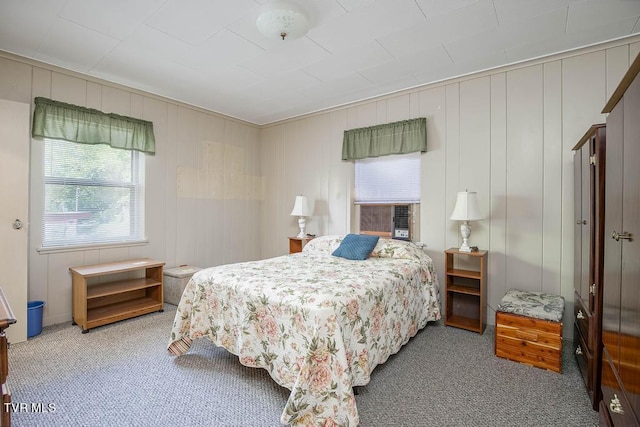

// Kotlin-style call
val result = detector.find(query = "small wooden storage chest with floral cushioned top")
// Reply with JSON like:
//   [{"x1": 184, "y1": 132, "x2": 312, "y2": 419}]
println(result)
[{"x1": 495, "y1": 289, "x2": 564, "y2": 373}]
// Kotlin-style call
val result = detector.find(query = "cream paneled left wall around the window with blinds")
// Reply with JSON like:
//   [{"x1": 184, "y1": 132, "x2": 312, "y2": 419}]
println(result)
[{"x1": 0, "y1": 54, "x2": 264, "y2": 325}]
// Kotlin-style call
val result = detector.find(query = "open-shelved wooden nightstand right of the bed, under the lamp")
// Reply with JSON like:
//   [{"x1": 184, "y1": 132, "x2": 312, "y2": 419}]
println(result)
[{"x1": 444, "y1": 248, "x2": 488, "y2": 334}]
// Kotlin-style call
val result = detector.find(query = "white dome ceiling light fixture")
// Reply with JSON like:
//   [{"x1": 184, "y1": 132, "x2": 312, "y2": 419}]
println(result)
[{"x1": 256, "y1": 0, "x2": 309, "y2": 40}]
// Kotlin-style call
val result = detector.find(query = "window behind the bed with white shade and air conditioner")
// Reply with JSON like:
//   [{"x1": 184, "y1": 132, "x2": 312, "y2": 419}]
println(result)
[{"x1": 355, "y1": 153, "x2": 420, "y2": 240}]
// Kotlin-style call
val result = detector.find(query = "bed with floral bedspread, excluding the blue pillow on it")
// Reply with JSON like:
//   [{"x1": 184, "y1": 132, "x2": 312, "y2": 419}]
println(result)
[{"x1": 168, "y1": 235, "x2": 441, "y2": 426}]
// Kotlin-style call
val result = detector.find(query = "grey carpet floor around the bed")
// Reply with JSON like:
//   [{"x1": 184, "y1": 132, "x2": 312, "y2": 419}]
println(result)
[{"x1": 8, "y1": 304, "x2": 598, "y2": 427}]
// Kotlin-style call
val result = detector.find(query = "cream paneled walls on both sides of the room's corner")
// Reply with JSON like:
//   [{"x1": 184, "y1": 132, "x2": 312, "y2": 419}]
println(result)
[{"x1": 0, "y1": 37, "x2": 640, "y2": 336}]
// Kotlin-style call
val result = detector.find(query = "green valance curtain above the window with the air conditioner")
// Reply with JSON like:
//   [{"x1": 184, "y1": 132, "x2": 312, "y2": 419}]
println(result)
[{"x1": 342, "y1": 117, "x2": 427, "y2": 160}]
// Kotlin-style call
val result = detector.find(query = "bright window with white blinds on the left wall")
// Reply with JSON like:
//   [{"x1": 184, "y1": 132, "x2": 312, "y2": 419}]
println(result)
[{"x1": 42, "y1": 139, "x2": 144, "y2": 248}]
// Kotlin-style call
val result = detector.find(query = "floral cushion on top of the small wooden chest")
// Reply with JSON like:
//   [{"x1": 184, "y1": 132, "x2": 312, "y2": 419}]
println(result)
[{"x1": 497, "y1": 289, "x2": 564, "y2": 322}]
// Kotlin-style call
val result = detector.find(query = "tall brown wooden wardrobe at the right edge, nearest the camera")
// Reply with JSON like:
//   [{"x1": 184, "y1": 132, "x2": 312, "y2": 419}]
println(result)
[{"x1": 600, "y1": 51, "x2": 640, "y2": 426}]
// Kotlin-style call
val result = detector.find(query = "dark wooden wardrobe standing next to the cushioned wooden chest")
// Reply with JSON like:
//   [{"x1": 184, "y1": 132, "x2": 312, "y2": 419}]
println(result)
[{"x1": 573, "y1": 124, "x2": 607, "y2": 411}]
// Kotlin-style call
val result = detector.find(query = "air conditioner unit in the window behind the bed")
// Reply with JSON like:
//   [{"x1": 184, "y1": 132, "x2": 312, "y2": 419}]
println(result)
[{"x1": 360, "y1": 204, "x2": 413, "y2": 240}]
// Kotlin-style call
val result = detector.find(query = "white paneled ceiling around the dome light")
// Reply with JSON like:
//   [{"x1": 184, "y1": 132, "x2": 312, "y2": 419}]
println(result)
[{"x1": 0, "y1": 0, "x2": 640, "y2": 125}]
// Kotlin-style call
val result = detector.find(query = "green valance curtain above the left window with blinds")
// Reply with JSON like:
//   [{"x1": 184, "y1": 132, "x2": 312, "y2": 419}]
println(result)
[{"x1": 32, "y1": 97, "x2": 156, "y2": 154}]
